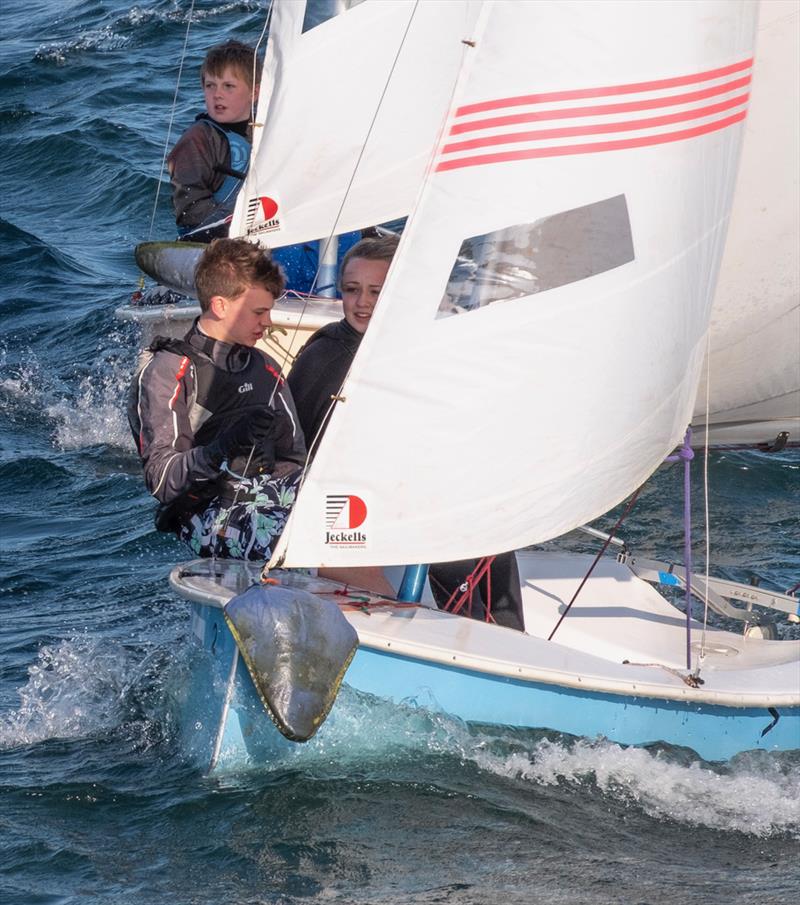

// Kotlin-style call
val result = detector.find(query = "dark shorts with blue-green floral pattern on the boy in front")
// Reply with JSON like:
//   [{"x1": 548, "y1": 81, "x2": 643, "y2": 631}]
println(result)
[{"x1": 178, "y1": 469, "x2": 302, "y2": 560}]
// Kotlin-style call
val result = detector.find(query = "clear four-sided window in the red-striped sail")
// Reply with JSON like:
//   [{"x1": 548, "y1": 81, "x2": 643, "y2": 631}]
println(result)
[{"x1": 436, "y1": 195, "x2": 634, "y2": 317}]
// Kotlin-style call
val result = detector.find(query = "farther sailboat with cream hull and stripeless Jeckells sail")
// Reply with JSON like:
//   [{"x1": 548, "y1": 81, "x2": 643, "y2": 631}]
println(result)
[{"x1": 116, "y1": 0, "x2": 477, "y2": 370}]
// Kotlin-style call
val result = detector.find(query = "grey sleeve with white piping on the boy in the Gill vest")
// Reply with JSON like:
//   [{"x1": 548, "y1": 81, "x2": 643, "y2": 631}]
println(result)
[{"x1": 129, "y1": 352, "x2": 220, "y2": 503}]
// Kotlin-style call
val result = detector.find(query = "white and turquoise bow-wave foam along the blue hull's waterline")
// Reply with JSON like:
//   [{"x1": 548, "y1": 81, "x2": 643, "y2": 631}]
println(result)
[{"x1": 202, "y1": 687, "x2": 800, "y2": 839}]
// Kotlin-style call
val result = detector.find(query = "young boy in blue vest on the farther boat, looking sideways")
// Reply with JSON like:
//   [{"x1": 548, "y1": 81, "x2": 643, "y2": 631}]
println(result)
[{"x1": 167, "y1": 41, "x2": 260, "y2": 242}]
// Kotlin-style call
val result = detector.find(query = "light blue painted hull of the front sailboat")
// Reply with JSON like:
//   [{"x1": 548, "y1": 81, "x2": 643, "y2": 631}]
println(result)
[{"x1": 183, "y1": 603, "x2": 800, "y2": 768}]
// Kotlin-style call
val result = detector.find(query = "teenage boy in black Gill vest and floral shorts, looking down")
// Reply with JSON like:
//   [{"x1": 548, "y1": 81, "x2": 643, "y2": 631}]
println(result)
[{"x1": 128, "y1": 239, "x2": 305, "y2": 560}]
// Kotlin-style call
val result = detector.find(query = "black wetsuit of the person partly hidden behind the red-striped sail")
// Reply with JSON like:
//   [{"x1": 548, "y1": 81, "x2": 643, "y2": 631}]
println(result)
[{"x1": 288, "y1": 320, "x2": 525, "y2": 631}]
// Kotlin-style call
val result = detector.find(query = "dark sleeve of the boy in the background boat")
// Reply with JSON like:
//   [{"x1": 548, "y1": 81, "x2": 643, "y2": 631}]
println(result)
[{"x1": 167, "y1": 121, "x2": 230, "y2": 233}]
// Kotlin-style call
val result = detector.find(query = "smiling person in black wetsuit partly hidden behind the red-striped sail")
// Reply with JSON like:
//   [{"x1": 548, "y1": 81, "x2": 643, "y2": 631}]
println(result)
[{"x1": 288, "y1": 236, "x2": 525, "y2": 631}]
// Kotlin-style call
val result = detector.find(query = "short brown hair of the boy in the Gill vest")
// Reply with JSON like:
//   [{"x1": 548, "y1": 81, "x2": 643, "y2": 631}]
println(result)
[{"x1": 194, "y1": 239, "x2": 286, "y2": 313}]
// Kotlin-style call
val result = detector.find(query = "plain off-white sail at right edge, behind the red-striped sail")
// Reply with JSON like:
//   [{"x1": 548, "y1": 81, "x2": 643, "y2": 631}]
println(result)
[{"x1": 693, "y1": 0, "x2": 800, "y2": 443}]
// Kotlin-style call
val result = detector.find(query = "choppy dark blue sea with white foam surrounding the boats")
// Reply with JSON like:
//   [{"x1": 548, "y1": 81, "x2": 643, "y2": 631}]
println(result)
[{"x1": 0, "y1": 0, "x2": 800, "y2": 905}]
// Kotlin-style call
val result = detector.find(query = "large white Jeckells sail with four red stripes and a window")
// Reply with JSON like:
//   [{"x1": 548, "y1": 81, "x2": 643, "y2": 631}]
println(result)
[{"x1": 274, "y1": 0, "x2": 756, "y2": 566}]
